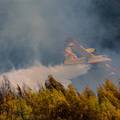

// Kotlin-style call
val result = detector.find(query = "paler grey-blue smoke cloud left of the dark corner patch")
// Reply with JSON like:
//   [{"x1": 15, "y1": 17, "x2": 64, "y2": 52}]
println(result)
[{"x1": 0, "y1": 0, "x2": 102, "y2": 71}]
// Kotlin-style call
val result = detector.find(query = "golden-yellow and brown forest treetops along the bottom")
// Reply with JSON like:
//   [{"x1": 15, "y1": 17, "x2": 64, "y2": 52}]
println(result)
[{"x1": 0, "y1": 75, "x2": 120, "y2": 120}]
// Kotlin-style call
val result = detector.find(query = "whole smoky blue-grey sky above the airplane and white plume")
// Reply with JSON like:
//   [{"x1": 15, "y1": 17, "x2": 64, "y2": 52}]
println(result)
[{"x1": 0, "y1": 0, "x2": 120, "y2": 90}]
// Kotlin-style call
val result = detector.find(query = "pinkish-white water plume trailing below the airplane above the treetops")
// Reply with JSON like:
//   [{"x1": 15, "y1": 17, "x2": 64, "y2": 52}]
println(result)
[{"x1": 0, "y1": 64, "x2": 90, "y2": 90}]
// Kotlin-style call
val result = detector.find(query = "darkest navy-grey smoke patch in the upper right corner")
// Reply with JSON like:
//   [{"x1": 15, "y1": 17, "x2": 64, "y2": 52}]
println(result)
[{"x1": 90, "y1": 0, "x2": 120, "y2": 53}]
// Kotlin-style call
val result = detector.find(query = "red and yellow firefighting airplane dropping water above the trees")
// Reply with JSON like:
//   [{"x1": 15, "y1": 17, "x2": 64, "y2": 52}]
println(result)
[{"x1": 64, "y1": 41, "x2": 112, "y2": 65}]
